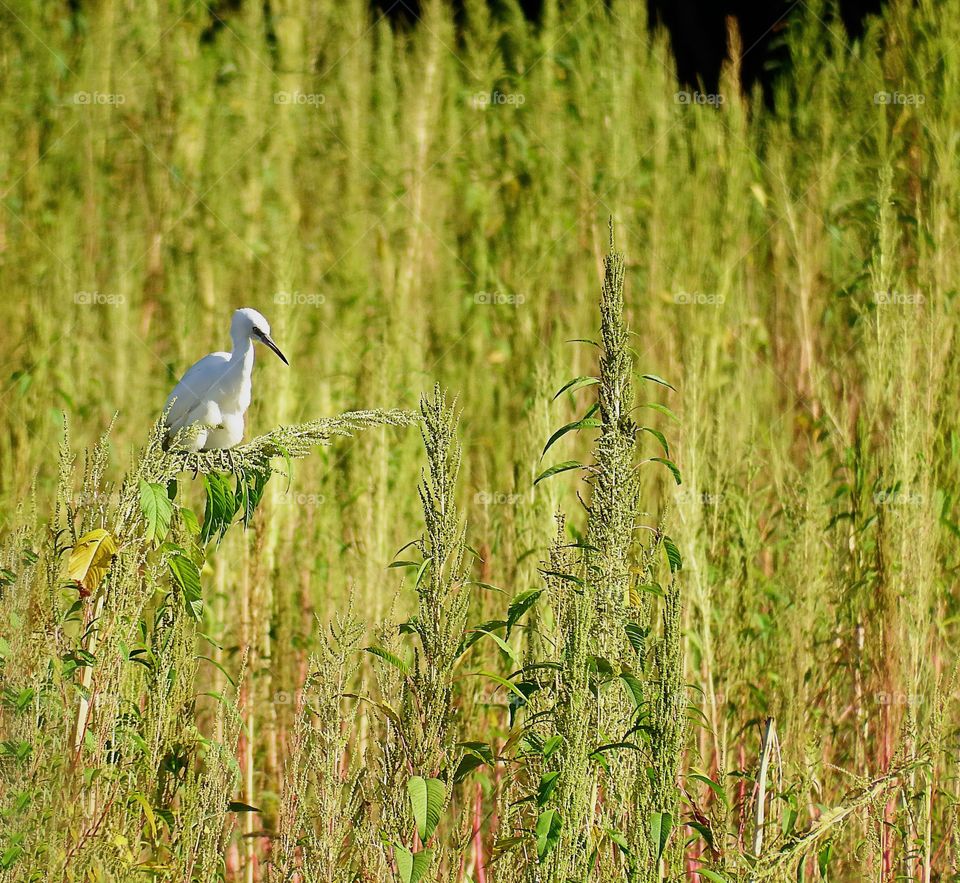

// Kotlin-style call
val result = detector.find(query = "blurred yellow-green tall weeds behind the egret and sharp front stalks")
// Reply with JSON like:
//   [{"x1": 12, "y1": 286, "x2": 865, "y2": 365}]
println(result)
[{"x1": 0, "y1": 0, "x2": 960, "y2": 879}]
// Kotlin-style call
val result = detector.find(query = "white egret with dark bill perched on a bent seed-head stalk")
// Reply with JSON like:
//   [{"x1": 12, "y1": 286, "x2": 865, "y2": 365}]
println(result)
[{"x1": 164, "y1": 307, "x2": 289, "y2": 452}]
